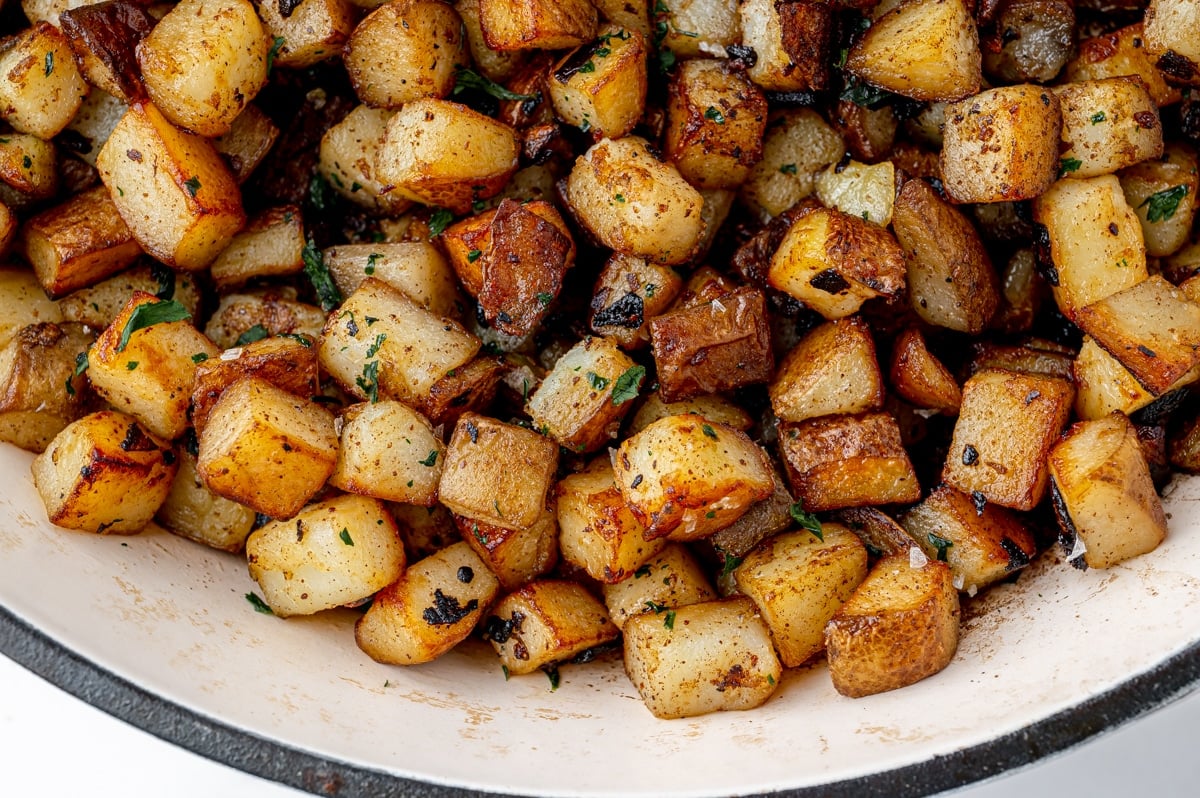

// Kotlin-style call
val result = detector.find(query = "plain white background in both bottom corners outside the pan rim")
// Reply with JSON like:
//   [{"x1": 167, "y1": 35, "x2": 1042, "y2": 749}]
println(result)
[{"x1": 0, "y1": 656, "x2": 1200, "y2": 798}]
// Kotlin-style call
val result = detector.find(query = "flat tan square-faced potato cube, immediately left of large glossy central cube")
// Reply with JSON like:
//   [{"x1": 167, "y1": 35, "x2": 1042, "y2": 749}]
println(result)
[{"x1": 438, "y1": 413, "x2": 558, "y2": 529}]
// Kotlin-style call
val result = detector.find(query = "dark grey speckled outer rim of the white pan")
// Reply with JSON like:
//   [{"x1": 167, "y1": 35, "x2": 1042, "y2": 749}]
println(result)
[{"x1": 0, "y1": 607, "x2": 1200, "y2": 798}]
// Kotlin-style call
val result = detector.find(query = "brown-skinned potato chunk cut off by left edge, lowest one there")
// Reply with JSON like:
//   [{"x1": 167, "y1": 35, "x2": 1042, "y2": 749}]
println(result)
[{"x1": 0, "y1": 322, "x2": 92, "y2": 451}]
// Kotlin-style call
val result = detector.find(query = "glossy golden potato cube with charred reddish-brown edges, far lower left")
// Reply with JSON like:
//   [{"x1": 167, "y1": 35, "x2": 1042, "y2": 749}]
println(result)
[{"x1": 32, "y1": 410, "x2": 179, "y2": 535}]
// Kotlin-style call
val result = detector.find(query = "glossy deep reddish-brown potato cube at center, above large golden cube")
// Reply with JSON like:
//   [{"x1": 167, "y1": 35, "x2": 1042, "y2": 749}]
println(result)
[{"x1": 649, "y1": 288, "x2": 775, "y2": 402}]
